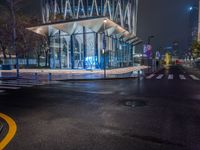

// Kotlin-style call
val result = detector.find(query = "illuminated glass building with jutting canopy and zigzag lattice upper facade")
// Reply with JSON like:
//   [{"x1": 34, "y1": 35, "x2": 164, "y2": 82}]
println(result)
[{"x1": 28, "y1": 0, "x2": 141, "y2": 69}]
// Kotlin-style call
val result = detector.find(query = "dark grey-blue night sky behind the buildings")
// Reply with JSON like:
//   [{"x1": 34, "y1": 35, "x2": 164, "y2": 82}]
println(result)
[{"x1": 0, "y1": 0, "x2": 197, "y2": 56}]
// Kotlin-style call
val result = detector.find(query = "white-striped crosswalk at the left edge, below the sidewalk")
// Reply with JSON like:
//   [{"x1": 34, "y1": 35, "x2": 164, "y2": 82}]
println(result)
[{"x1": 0, "y1": 80, "x2": 49, "y2": 94}]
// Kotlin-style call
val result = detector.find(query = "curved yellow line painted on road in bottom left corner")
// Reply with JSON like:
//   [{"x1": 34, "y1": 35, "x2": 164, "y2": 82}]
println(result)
[{"x1": 0, "y1": 113, "x2": 17, "y2": 150}]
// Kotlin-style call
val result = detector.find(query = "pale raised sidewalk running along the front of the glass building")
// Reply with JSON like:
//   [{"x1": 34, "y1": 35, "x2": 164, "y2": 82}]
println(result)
[{"x1": 0, "y1": 66, "x2": 148, "y2": 81}]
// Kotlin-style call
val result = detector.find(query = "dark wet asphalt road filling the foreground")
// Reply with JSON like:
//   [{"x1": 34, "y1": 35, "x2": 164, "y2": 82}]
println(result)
[{"x1": 0, "y1": 66, "x2": 200, "y2": 150}]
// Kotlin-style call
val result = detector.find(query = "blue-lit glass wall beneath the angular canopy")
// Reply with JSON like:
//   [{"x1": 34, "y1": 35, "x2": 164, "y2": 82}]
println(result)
[{"x1": 49, "y1": 26, "x2": 133, "y2": 69}]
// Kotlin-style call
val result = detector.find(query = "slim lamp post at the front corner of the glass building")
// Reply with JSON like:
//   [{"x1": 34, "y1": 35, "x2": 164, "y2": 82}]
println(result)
[{"x1": 102, "y1": 19, "x2": 107, "y2": 79}]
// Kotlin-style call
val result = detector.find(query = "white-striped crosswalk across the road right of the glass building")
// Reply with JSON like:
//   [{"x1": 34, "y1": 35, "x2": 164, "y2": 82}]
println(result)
[{"x1": 146, "y1": 74, "x2": 200, "y2": 81}]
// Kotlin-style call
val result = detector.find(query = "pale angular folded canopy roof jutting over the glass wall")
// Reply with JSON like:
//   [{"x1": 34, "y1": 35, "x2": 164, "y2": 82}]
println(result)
[{"x1": 27, "y1": 17, "x2": 142, "y2": 45}]
